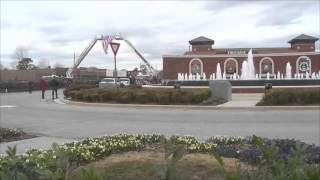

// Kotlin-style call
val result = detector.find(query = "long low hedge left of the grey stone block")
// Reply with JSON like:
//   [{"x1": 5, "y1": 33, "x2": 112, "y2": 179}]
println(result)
[{"x1": 64, "y1": 88, "x2": 211, "y2": 105}]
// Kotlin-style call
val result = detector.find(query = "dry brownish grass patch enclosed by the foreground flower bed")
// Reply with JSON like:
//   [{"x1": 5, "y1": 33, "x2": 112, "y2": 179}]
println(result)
[{"x1": 70, "y1": 148, "x2": 249, "y2": 180}]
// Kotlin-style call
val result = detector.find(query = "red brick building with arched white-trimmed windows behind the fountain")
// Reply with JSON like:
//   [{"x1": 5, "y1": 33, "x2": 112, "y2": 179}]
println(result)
[{"x1": 163, "y1": 34, "x2": 320, "y2": 80}]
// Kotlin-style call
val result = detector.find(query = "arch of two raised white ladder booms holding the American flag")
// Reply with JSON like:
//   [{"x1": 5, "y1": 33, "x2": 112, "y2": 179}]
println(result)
[{"x1": 66, "y1": 34, "x2": 157, "y2": 78}]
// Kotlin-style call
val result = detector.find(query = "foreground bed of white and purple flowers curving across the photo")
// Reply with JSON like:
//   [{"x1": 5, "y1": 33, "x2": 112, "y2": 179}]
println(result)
[{"x1": 0, "y1": 134, "x2": 320, "y2": 179}]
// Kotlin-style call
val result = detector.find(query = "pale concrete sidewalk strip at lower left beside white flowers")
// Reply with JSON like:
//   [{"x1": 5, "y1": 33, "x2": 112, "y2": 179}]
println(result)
[{"x1": 0, "y1": 137, "x2": 77, "y2": 154}]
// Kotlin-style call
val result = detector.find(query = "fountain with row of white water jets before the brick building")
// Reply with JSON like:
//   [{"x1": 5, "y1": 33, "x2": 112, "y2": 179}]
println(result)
[{"x1": 172, "y1": 49, "x2": 320, "y2": 86}]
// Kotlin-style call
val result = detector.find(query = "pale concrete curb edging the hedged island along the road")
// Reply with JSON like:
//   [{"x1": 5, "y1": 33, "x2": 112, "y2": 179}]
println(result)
[{"x1": 61, "y1": 99, "x2": 320, "y2": 111}]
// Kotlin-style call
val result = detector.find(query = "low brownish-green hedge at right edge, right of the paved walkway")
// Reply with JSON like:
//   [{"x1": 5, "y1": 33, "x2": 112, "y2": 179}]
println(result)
[{"x1": 257, "y1": 89, "x2": 320, "y2": 106}]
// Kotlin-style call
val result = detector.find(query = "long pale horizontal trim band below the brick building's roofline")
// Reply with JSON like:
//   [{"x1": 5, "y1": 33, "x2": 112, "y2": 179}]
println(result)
[{"x1": 162, "y1": 52, "x2": 320, "y2": 58}]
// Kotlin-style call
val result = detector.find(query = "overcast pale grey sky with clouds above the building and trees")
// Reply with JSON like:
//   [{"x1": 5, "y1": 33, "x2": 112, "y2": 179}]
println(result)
[{"x1": 0, "y1": 0, "x2": 320, "y2": 69}]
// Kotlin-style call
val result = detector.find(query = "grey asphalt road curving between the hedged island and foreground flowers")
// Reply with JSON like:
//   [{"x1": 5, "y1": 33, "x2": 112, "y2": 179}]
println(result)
[{"x1": 0, "y1": 91, "x2": 320, "y2": 145}]
